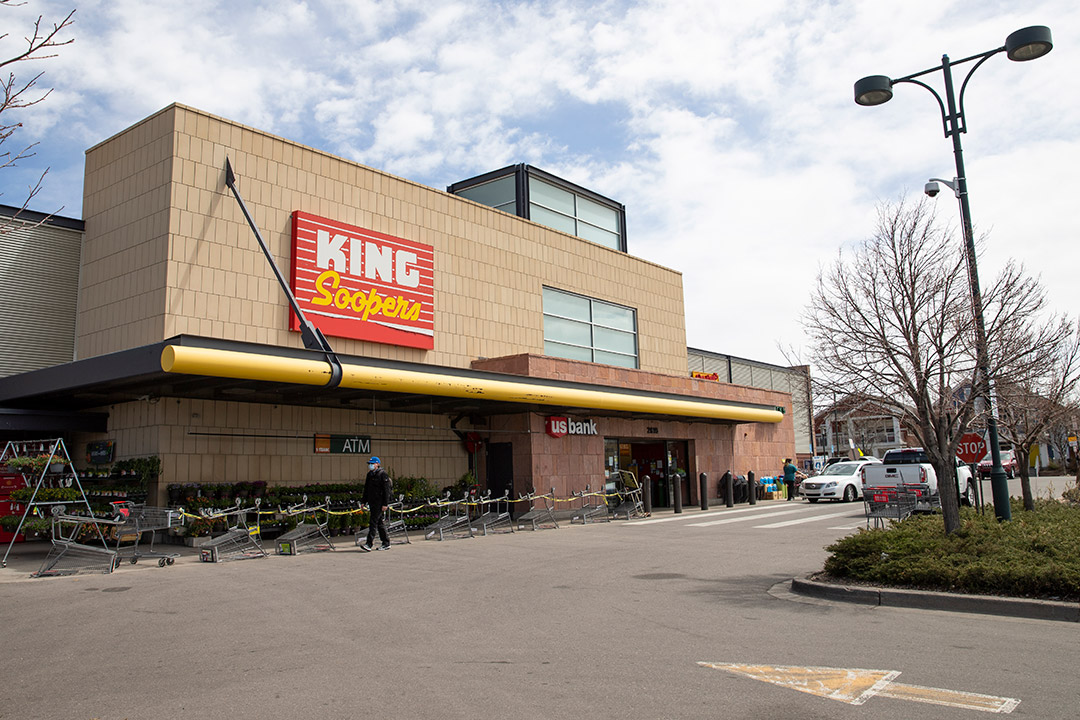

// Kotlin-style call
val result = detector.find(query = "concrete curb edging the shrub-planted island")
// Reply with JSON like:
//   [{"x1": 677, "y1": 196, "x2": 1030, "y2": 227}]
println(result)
[{"x1": 792, "y1": 576, "x2": 1080, "y2": 623}]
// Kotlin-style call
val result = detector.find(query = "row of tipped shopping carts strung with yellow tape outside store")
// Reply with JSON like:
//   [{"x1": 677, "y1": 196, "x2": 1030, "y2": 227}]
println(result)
[{"x1": 23, "y1": 473, "x2": 645, "y2": 578}]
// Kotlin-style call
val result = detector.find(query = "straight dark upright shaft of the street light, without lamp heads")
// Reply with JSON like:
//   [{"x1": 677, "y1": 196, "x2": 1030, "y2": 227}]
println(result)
[{"x1": 942, "y1": 55, "x2": 1012, "y2": 520}]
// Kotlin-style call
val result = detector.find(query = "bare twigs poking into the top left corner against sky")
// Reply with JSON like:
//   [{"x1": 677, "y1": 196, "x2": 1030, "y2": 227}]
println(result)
[{"x1": 0, "y1": 0, "x2": 75, "y2": 225}]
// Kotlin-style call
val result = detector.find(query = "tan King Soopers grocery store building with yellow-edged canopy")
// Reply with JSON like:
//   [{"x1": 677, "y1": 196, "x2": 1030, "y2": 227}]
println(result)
[{"x1": 0, "y1": 105, "x2": 805, "y2": 506}]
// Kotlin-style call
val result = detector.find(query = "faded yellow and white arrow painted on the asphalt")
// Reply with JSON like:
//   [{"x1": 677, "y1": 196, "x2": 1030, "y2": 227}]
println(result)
[{"x1": 698, "y1": 663, "x2": 1020, "y2": 714}]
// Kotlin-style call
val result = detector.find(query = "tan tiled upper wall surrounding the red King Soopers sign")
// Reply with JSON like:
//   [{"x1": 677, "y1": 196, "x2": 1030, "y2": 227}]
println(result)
[{"x1": 79, "y1": 106, "x2": 687, "y2": 375}]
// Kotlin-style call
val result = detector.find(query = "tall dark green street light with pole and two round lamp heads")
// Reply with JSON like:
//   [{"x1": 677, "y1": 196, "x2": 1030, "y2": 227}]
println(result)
[{"x1": 855, "y1": 25, "x2": 1054, "y2": 520}]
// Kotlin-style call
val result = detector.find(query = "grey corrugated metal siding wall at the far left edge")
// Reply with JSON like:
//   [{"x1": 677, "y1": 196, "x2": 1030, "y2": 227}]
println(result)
[{"x1": 0, "y1": 218, "x2": 82, "y2": 377}]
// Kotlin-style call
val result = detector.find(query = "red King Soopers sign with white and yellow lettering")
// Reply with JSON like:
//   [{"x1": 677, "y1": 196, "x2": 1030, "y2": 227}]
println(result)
[{"x1": 289, "y1": 210, "x2": 435, "y2": 350}]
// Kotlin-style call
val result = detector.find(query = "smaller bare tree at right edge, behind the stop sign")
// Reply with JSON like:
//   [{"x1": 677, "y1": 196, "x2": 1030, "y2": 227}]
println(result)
[{"x1": 997, "y1": 317, "x2": 1080, "y2": 510}]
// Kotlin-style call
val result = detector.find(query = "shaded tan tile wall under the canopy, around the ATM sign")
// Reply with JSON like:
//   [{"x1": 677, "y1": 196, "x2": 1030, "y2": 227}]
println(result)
[{"x1": 72, "y1": 398, "x2": 468, "y2": 502}]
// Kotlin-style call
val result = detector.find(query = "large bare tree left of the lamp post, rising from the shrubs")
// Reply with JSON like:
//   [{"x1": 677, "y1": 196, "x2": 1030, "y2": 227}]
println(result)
[{"x1": 805, "y1": 200, "x2": 1062, "y2": 533}]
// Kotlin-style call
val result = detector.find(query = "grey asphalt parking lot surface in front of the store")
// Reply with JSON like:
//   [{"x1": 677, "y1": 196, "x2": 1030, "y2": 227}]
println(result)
[{"x1": 0, "y1": 492, "x2": 1077, "y2": 720}]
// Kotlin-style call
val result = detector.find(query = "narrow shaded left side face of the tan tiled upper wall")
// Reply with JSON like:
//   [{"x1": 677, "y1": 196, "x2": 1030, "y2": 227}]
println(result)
[{"x1": 76, "y1": 113, "x2": 174, "y2": 358}]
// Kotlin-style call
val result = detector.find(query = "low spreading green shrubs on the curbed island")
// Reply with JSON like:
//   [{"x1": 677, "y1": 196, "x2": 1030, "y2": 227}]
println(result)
[{"x1": 824, "y1": 500, "x2": 1080, "y2": 600}]
